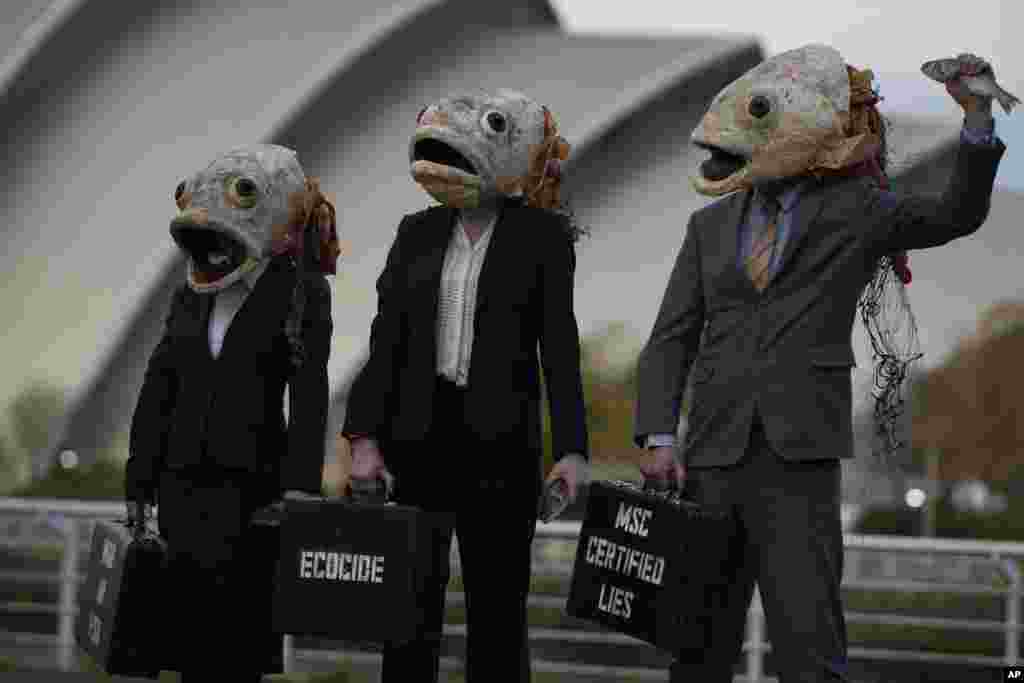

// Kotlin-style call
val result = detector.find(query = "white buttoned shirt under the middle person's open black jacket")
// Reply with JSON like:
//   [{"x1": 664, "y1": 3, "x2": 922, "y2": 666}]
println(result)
[{"x1": 437, "y1": 217, "x2": 497, "y2": 386}]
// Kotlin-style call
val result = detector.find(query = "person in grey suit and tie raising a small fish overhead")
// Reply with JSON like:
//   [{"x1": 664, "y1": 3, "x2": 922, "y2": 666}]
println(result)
[{"x1": 635, "y1": 46, "x2": 1005, "y2": 683}]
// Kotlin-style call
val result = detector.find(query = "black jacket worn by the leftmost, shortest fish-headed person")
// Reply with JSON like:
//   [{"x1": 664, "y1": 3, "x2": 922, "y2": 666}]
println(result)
[{"x1": 126, "y1": 257, "x2": 332, "y2": 501}]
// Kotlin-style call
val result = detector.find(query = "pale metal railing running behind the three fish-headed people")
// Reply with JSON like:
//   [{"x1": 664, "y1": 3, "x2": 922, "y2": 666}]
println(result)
[{"x1": 0, "y1": 498, "x2": 1024, "y2": 682}]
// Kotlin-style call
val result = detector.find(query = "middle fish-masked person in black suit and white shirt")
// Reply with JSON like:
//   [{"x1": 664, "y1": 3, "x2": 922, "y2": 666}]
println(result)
[{"x1": 343, "y1": 91, "x2": 587, "y2": 683}]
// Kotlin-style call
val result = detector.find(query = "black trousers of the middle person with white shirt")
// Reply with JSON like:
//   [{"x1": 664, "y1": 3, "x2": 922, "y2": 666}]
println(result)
[{"x1": 381, "y1": 380, "x2": 541, "y2": 683}]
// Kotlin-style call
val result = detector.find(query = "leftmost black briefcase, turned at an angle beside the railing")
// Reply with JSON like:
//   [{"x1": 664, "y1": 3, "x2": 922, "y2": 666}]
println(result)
[{"x1": 75, "y1": 520, "x2": 166, "y2": 678}]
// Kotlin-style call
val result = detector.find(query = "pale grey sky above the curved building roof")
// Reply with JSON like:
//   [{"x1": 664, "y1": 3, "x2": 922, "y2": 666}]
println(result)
[{"x1": 552, "y1": 0, "x2": 1024, "y2": 189}]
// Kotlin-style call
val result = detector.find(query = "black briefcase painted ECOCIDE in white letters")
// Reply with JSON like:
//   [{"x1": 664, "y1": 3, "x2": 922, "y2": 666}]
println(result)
[{"x1": 273, "y1": 499, "x2": 433, "y2": 645}]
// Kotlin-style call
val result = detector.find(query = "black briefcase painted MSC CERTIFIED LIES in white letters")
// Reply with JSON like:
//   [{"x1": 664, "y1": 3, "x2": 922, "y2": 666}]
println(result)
[{"x1": 566, "y1": 481, "x2": 734, "y2": 652}]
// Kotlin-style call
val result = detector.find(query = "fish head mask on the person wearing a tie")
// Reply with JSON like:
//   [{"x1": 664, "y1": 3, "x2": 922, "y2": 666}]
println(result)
[{"x1": 690, "y1": 45, "x2": 881, "y2": 196}]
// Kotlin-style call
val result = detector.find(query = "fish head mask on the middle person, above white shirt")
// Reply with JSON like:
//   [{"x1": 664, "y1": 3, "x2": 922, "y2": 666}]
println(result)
[{"x1": 409, "y1": 90, "x2": 569, "y2": 208}]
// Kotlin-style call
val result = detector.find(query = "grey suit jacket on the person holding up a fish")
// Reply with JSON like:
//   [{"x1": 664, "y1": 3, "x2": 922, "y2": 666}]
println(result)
[{"x1": 636, "y1": 142, "x2": 1005, "y2": 467}]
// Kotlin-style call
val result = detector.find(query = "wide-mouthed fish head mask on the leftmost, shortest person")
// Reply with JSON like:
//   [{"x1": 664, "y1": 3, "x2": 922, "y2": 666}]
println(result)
[{"x1": 170, "y1": 144, "x2": 340, "y2": 293}]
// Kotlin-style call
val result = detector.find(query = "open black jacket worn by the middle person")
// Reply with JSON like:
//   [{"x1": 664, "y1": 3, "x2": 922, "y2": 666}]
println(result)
[{"x1": 343, "y1": 207, "x2": 587, "y2": 467}]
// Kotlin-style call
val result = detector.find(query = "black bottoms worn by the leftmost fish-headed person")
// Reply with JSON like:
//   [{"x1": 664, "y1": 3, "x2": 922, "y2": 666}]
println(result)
[{"x1": 157, "y1": 467, "x2": 284, "y2": 683}]
